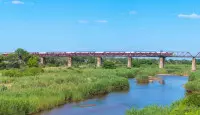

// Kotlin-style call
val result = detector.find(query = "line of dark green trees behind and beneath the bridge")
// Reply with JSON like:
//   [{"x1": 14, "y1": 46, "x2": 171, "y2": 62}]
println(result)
[{"x1": 0, "y1": 48, "x2": 200, "y2": 69}]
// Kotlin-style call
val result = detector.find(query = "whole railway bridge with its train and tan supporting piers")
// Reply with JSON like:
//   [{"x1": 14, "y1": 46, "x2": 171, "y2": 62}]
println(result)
[{"x1": 1, "y1": 51, "x2": 200, "y2": 71}]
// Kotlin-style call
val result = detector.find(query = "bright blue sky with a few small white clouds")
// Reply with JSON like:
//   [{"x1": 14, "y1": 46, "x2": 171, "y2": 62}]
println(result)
[{"x1": 0, "y1": 0, "x2": 200, "y2": 52}]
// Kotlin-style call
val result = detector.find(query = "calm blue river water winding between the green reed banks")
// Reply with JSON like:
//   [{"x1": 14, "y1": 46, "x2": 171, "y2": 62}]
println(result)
[{"x1": 36, "y1": 76, "x2": 188, "y2": 115}]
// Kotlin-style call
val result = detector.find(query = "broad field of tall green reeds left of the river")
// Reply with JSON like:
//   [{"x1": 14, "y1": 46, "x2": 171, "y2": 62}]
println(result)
[{"x1": 0, "y1": 65, "x2": 194, "y2": 115}]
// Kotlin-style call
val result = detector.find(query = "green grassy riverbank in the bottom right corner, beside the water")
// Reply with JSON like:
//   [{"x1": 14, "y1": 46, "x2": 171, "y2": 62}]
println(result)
[{"x1": 126, "y1": 71, "x2": 200, "y2": 115}]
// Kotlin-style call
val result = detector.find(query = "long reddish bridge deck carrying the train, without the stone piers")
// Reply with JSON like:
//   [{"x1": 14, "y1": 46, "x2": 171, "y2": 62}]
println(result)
[{"x1": 23, "y1": 51, "x2": 194, "y2": 58}]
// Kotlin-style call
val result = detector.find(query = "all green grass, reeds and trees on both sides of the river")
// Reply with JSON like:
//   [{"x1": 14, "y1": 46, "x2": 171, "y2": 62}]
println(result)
[{"x1": 0, "y1": 48, "x2": 200, "y2": 115}]
